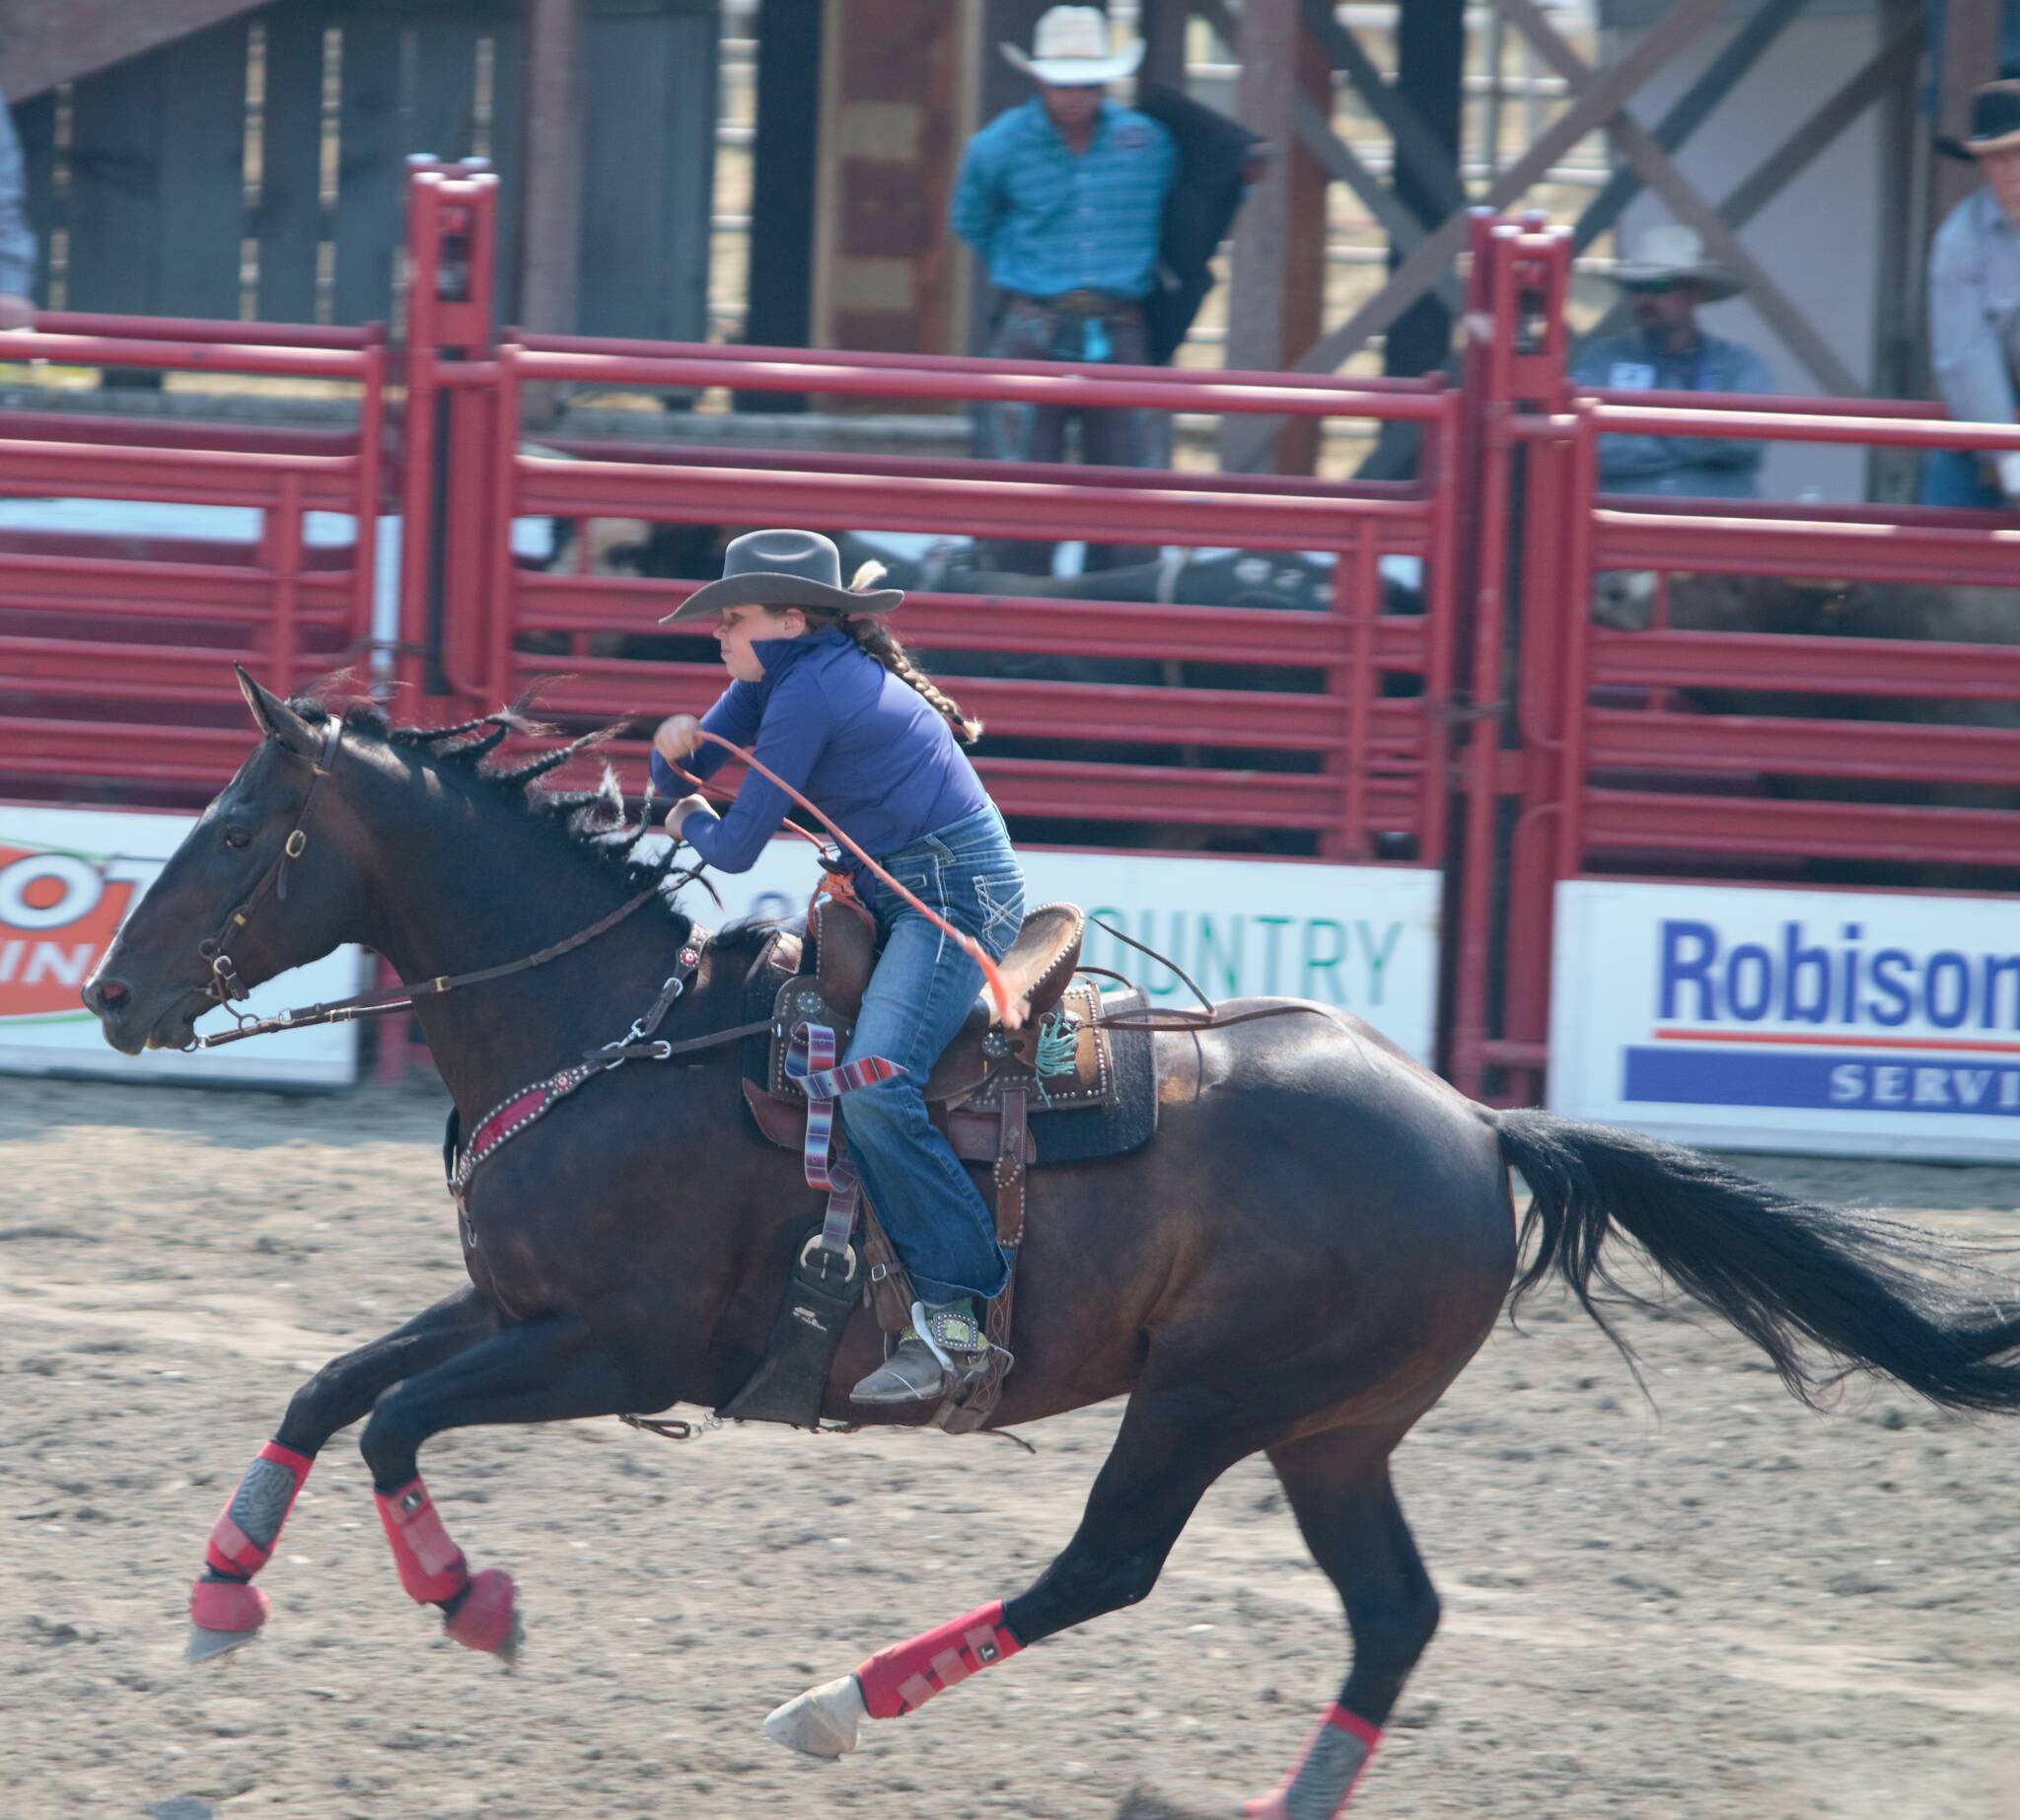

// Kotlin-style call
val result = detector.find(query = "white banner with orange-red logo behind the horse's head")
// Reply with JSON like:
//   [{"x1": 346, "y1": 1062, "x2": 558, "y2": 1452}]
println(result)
[{"x1": 0, "y1": 804, "x2": 364, "y2": 1087}]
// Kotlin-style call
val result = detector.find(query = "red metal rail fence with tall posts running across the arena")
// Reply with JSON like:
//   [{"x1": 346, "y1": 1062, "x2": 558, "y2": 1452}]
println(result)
[{"x1": 0, "y1": 170, "x2": 2020, "y2": 1097}]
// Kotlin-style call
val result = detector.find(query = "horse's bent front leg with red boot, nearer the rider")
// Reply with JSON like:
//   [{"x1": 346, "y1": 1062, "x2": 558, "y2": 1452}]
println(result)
[{"x1": 357, "y1": 1315, "x2": 625, "y2": 1664}]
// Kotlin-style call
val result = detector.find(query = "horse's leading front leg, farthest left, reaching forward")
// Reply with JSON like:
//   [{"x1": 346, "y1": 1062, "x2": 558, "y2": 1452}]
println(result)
[{"x1": 190, "y1": 1288, "x2": 499, "y2": 1662}]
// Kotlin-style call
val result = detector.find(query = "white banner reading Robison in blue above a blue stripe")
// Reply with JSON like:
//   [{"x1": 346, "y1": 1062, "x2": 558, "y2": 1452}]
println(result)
[{"x1": 1550, "y1": 879, "x2": 2020, "y2": 1161}]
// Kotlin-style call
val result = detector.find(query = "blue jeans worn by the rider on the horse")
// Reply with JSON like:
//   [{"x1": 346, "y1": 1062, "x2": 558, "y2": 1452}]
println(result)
[{"x1": 836, "y1": 804, "x2": 1024, "y2": 1303}]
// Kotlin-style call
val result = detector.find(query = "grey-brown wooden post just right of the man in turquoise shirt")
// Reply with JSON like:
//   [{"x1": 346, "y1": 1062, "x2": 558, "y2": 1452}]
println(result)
[{"x1": 1220, "y1": 0, "x2": 1299, "y2": 469}]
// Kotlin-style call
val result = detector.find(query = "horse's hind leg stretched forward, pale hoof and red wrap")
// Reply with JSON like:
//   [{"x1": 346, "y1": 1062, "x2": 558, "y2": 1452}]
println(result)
[{"x1": 763, "y1": 1388, "x2": 1261, "y2": 1758}]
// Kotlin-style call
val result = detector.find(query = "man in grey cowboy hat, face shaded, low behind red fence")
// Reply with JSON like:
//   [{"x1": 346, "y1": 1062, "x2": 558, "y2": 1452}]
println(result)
[{"x1": 1571, "y1": 224, "x2": 1773, "y2": 499}]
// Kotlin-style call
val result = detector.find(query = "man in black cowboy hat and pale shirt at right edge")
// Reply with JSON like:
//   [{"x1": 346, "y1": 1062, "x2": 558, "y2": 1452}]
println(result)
[{"x1": 1921, "y1": 79, "x2": 2020, "y2": 507}]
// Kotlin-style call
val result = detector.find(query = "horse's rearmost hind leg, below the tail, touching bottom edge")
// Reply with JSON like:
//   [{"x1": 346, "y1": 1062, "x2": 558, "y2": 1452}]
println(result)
[{"x1": 1243, "y1": 1428, "x2": 1438, "y2": 1820}]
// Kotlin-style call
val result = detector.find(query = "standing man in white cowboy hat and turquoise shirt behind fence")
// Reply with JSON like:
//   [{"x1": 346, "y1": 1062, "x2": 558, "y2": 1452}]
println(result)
[{"x1": 952, "y1": 6, "x2": 1178, "y2": 569}]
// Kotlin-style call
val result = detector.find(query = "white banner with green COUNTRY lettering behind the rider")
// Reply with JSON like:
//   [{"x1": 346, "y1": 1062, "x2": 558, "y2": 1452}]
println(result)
[{"x1": 702, "y1": 838, "x2": 1440, "y2": 1064}]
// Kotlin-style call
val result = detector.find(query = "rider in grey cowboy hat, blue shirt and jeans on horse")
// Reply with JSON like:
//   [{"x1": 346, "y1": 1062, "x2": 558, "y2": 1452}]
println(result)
[{"x1": 653, "y1": 532, "x2": 1024, "y2": 1404}]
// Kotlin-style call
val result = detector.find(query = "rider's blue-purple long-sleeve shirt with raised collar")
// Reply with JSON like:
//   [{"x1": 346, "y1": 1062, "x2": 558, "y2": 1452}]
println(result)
[{"x1": 653, "y1": 626, "x2": 990, "y2": 873}]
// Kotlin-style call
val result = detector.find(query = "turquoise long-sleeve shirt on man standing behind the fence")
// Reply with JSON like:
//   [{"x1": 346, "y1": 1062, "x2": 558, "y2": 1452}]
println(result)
[{"x1": 952, "y1": 95, "x2": 1178, "y2": 297}]
